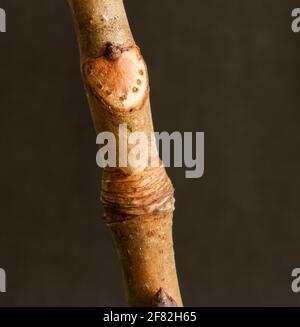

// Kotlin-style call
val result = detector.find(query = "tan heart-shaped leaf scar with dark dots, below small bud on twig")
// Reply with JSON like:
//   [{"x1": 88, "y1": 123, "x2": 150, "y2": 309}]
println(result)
[{"x1": 83, "y1": 47, "x2": 148, "y2": 112}]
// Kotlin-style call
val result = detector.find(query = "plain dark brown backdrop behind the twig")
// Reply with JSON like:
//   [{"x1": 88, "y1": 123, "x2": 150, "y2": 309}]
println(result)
[{"x1": 0, "y1": 0, "x2": 300, "y2": 306}]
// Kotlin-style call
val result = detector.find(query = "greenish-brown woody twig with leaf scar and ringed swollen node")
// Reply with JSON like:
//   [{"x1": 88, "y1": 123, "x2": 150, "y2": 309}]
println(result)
[{"x1": 68, "y1": 0, "x2": 182, "y2": 306}]
